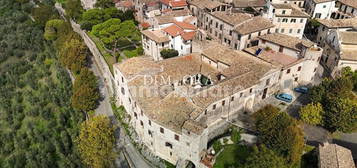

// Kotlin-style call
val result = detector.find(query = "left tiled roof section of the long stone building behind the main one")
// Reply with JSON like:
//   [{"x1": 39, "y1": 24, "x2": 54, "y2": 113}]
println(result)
[{"x1": 212, "y1": 11, "x2": 251, "y2": 26}]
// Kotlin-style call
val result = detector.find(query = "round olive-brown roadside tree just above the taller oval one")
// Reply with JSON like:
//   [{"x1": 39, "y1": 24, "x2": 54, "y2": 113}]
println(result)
[{"x1": 59, "y1": 38, "x2": 87, "y2": 73}]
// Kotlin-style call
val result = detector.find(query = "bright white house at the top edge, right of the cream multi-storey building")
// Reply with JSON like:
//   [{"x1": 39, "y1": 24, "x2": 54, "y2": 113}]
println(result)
[{"x1": 305, "y1": 0, "x2": 337, "y2": 19}]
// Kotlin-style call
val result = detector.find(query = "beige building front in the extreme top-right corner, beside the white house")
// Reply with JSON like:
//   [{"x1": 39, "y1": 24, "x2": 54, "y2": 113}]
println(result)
[{"x1": 331, "y1": 0, "x2": 357, "y2": 19}]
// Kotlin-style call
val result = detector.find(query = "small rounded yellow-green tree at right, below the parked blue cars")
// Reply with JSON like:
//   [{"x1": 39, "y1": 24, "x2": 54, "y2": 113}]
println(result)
[{"x1": 300, "y1": 103, "x2": 324, "y2": 125}]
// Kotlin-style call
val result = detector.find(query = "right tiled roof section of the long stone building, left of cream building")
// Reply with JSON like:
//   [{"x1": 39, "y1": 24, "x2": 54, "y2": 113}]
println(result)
[{"x1": 234, "y1": 16, "x2": 275, "y2": 34}]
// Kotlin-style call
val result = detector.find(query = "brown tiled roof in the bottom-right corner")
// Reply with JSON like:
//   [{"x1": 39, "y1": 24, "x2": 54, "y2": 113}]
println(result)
[{"x1": 318, "y1": 143, "x2": 355, "y2": 168}]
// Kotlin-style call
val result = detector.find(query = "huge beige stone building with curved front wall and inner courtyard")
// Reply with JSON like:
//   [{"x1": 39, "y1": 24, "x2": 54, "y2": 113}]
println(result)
[{"x1": 114, "y1": 45, "x2": 280, "y2": 168}]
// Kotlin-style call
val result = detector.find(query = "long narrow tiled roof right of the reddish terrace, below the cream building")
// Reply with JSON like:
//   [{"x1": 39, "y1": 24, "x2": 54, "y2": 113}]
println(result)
[{"x1": 258, "y1": 33, "x2": 314, "y2": 51}]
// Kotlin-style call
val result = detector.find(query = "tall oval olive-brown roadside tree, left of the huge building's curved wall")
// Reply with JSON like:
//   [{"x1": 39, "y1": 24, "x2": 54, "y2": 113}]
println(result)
[{"x1": 71, "y1": 68, "x2": 100, "y2": 114}]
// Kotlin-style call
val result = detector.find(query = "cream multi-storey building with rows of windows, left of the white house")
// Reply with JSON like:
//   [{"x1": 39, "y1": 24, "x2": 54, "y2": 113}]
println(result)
[{"x1": 264, "y1": 3, "x2": 310, "y2": 39}]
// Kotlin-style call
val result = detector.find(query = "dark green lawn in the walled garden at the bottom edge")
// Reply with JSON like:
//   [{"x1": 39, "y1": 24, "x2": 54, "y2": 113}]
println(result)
[{"x1": 213, "y1": 144, "x2": 249, "y2": 168}]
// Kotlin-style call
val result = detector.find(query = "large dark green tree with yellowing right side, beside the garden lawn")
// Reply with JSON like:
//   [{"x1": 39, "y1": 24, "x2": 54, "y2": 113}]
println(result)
[{"x1": 254, "y1": 105, "x2": 304, "y2": 164}]
